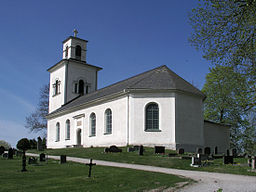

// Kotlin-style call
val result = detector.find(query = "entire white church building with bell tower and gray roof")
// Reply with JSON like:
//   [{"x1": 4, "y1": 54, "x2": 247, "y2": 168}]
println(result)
[{"x1": 47, "y1": 35, "x2": 229, "y2": 153}]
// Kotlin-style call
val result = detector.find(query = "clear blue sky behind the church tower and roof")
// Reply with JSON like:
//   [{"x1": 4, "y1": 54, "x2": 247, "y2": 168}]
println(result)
[{"x1": 0, "y1": 0, "x2": 211, "y2": 146}]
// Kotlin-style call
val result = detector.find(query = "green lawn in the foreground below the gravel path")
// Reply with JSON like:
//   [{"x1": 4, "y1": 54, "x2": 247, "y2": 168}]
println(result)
[{"x1": 0, "y1": 157, "x2": 188, "y2": 192}]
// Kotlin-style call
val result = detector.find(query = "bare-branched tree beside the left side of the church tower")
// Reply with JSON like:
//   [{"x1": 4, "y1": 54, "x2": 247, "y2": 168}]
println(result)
[{"x1": 25, "y1": 84, "x2": 49, "y2": 132}]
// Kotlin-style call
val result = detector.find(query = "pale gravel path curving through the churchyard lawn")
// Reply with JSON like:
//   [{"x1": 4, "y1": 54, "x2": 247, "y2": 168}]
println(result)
[{"x1": 27, "y1": 153, "x2": 256, "y2": 192}]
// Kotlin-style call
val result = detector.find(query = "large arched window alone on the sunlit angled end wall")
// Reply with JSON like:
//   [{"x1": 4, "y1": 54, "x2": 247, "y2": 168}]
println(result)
[{"x1": 145, "y1": 103, "x2": 159, "y2": 130}]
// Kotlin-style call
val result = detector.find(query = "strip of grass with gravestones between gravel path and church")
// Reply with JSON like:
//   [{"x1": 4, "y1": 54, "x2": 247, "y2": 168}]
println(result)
[{"x1": 28, "y1": 147, "x2": 256, "y2": 176}]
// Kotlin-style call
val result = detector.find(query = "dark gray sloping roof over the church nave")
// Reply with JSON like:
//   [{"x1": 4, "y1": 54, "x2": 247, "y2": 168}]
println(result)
[{"x1": 48, "y1": 65, "x2": 205, "y2": 115}]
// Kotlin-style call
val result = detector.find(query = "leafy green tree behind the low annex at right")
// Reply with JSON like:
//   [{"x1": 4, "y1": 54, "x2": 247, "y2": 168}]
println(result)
[{"x1": 202, "y1": 65, "x2": 255, "y2": 149}]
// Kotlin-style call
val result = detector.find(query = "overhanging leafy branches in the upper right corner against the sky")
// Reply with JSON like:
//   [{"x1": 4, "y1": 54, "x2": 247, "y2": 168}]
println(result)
[{"x1": 189, "y1": 0, "x2": 256, "y2": 110}]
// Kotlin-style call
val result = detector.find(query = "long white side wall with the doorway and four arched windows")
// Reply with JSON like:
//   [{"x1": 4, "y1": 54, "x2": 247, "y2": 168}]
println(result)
[{"x1": 47, "y1": 97, "x2": 127, "y2": 148}]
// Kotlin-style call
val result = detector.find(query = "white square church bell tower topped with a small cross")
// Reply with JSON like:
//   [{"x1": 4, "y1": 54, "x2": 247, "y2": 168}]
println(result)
[{"x1": 48, "y1": 30, "x2": 102, "y2": 113}]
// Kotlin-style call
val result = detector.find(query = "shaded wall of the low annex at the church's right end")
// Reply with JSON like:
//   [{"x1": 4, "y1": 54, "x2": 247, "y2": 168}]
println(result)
[{"x1": 204, "y1": 121, "x2": 230, "y2": 153}]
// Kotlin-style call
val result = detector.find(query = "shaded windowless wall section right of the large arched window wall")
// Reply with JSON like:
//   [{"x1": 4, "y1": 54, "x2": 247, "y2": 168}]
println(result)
[{"x1": 175, "y1": 93, "x2": 204, "y2": 152}]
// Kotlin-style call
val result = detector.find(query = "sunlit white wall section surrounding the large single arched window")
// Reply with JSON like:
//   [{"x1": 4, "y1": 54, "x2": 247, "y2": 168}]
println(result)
[{"x1": 129, "y1": 93, "x2": 175, "y2": 149}]
